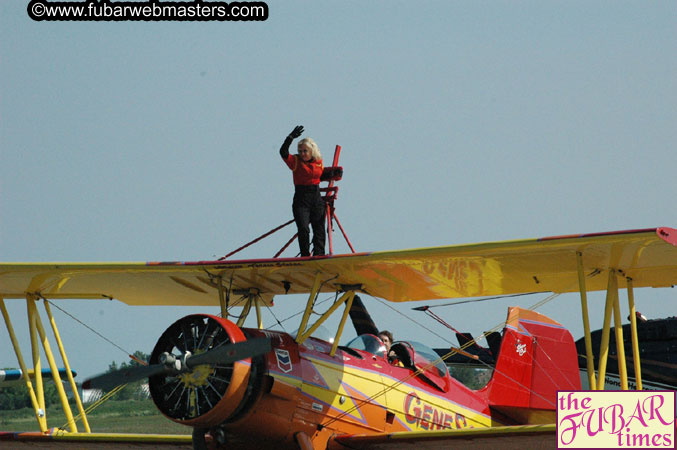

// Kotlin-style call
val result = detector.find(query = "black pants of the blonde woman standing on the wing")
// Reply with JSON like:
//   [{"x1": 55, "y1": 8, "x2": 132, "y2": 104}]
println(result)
[{"x1": 292, "y1": 186, "x2": 326, "y2": 256}]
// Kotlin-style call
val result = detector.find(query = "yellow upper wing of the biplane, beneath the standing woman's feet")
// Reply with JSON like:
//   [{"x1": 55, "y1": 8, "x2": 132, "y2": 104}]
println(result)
[{"x1": 0, "y1": 228, "x2": 677, "y2": 305}]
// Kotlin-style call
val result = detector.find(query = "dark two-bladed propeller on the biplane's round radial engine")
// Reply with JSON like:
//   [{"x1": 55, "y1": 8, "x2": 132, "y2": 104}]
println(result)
[{"x1": 82, "y1": 338, "x2": 271, "y2": 391}]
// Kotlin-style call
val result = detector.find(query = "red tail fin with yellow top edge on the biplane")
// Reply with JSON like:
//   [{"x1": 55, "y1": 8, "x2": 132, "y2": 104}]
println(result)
[{"x1": 487, "y1": 307, "x2": 581, "y2": 423}]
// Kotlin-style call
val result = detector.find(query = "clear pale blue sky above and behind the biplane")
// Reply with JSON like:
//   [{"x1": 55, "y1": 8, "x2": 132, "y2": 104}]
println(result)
[{"x1": 0, "y1": 1, "x2": 677, "y2": 382}]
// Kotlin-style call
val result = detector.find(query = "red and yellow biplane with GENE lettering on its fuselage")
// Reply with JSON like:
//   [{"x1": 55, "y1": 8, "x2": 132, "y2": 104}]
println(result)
[{"x1": 0, "y1": 227, "x2": 677, "y2": 449}]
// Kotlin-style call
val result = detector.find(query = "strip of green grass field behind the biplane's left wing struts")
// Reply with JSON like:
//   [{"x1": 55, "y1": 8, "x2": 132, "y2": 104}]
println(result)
[{"x1": 0, "y1": 400, "x2": 192, "y2": 434}]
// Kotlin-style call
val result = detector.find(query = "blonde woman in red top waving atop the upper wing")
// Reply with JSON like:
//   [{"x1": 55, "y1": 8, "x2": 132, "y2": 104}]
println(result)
[{"x1": 280, "y1": 125, "x2": 326, "y2": 256}]
